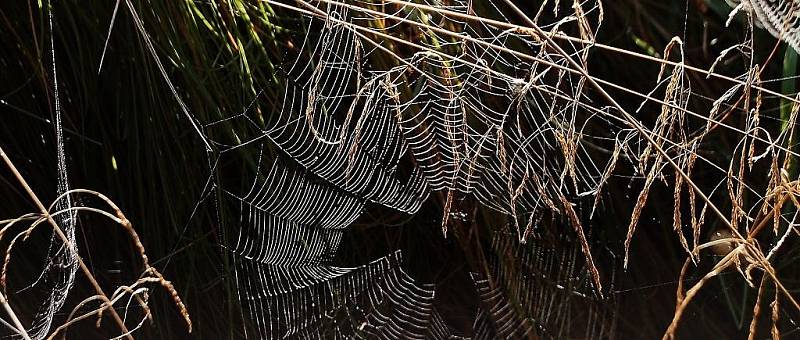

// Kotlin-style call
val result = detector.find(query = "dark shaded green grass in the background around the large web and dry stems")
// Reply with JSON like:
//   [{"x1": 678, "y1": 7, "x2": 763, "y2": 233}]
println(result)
[{"x1": 0, "y1": 0, "x2": 797, "y2": 339}]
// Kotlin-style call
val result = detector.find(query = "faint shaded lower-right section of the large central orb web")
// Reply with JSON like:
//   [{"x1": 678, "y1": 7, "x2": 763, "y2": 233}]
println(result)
[{"x1": 471, "y1": 231, "x2": 615, "y2": 339}]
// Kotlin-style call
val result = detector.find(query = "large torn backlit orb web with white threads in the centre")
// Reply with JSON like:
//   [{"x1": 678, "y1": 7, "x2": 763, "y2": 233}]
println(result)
[{"x1": 204, "y1": 1, "x2": 620, "y2": 339}]
